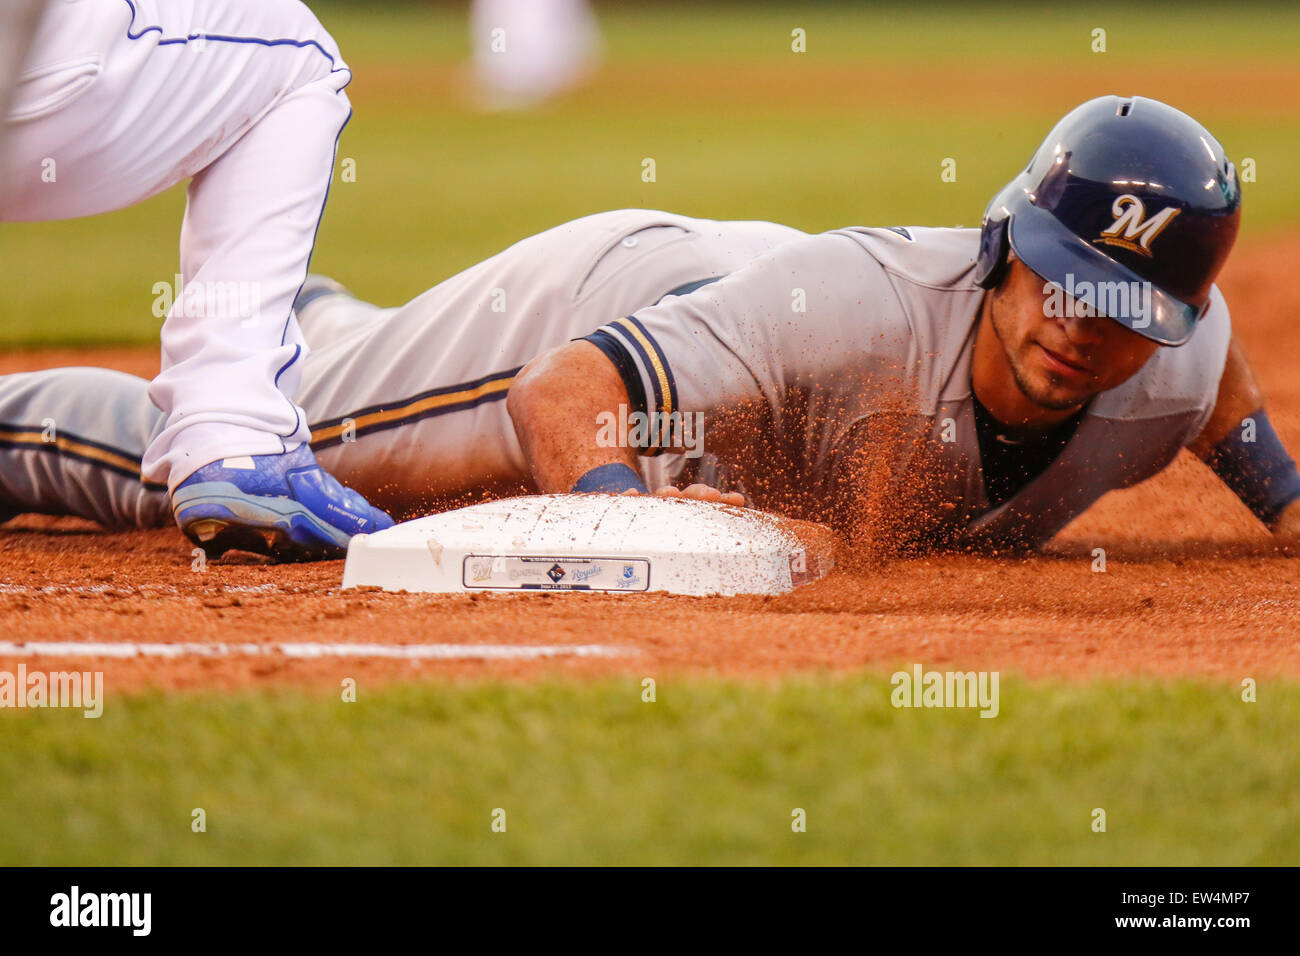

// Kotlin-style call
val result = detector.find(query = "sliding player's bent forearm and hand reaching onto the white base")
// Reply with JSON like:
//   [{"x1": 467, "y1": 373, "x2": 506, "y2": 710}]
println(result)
[{"x1": 506, "y1": 339, "x2": 744, "y2": 505}]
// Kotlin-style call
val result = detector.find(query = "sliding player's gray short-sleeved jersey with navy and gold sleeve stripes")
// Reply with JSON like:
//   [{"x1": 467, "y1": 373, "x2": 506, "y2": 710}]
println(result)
[{"x1": 592, "y1": 229, "x2": 1231, "y2": 548}]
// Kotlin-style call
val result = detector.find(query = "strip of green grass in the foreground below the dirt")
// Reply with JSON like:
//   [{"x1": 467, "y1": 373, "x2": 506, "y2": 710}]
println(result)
[{"x1": 0, "y1": 676, "x2": 1300, "y2": 865}]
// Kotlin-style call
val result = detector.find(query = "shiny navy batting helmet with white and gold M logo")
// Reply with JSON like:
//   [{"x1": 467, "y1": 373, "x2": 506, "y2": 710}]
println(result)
[{"x1": 975, "y1": 96, "x2": 1242, "y2": 345}]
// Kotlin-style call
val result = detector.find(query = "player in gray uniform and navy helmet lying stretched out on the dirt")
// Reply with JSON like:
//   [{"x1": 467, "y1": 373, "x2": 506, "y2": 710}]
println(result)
[{"x1": 0, "y1": 96, "x2": 1300, "y2": 561}]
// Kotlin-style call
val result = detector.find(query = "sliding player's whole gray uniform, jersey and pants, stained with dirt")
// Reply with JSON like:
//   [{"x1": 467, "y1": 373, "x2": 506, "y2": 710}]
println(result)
[{"x1": 0, "y1": 209, "x2": 1230, "y2": 546}]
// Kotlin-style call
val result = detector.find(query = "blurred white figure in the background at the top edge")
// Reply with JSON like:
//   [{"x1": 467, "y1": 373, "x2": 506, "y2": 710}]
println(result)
[{"x1": 469, "y1": 0, "x2": 601, "y2": 109}]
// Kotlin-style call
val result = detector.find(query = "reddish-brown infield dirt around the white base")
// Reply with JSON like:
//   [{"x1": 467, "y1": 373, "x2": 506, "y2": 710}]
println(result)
[{"x1": 0, "y1": 237, "x2": 1300, "y2": 689}]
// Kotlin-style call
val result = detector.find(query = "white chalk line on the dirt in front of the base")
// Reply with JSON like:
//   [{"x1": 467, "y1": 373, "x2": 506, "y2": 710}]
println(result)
[{"x1": 0, "y1": 641, "x2": 636, "y2": 661}]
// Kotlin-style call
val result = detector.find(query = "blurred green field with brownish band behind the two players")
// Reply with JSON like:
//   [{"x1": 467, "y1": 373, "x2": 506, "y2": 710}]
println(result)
[{"x1": 0, "y1": 4, "x2": 1300, "y2": 347}]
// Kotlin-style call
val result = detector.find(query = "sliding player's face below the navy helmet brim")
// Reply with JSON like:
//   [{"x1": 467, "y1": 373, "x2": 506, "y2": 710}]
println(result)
[{"x1": 992, "y1": 259, "x2": 1160, "y2": 410}]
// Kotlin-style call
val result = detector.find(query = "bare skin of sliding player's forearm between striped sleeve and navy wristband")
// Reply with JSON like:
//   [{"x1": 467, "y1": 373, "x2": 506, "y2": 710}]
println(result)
[{"x1": 506, "y1": 342, "x2": 637, "y2": 493}]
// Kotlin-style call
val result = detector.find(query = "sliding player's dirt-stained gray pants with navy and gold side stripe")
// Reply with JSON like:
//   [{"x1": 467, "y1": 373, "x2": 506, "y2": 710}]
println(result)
[{"x1": 0, "y1": 209, "x2": 805, "y2": 527}]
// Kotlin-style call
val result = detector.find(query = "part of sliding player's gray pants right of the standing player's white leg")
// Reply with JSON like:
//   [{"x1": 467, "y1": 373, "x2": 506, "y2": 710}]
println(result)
[{"x1": 298, "y1": 209, "x2": 805, "y2": 514}]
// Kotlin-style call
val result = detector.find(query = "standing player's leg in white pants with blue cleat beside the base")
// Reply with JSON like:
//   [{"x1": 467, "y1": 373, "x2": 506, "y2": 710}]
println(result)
[{"x1": 0, "y1": 0, "x2": 391, "y2": 558}]
